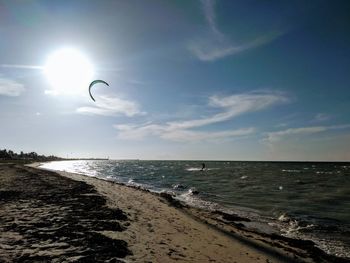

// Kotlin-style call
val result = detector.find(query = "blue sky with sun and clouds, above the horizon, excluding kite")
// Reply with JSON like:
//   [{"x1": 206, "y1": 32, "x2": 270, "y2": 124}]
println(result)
[{"x1": 0, "y1": 0, "x2": 350, "y2": 161}]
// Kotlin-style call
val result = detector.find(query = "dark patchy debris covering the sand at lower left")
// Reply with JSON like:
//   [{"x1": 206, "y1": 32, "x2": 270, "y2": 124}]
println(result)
[{"x1": 0, "y1": 164, "x2": 131, "y2": 262}]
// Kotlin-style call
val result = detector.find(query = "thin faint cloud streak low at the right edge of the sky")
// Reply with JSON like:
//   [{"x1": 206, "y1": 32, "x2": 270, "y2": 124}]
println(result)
[{"x1": 263, "y1": 124, "x2": 350, "y2": 143}]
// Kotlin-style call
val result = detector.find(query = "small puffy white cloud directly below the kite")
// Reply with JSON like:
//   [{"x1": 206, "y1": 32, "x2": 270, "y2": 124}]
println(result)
[{"x1": 77, "y1": 96, "x2": 145, "y2": 117}]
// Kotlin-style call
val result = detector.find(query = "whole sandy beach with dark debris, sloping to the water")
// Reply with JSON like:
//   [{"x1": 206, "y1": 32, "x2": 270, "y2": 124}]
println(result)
[{"x1": 0, "y1": 164, "x2": 346, "y2": 262}]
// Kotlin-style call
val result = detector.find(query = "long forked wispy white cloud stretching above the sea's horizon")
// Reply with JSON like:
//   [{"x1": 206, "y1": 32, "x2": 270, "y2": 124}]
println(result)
[{"x1": 114, "y1": 92, "x2": 288, "y2": 142}]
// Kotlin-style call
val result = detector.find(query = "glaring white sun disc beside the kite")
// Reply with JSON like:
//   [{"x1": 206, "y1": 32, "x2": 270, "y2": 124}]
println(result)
[{"x1": 44, "y1": 48, "x2": 94, "y2": 95}]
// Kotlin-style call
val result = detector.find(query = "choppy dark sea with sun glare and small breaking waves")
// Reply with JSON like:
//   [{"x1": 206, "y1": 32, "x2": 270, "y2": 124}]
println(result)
[{"x1": 42, "y1": 160, "x2": 350, "y2": 257}]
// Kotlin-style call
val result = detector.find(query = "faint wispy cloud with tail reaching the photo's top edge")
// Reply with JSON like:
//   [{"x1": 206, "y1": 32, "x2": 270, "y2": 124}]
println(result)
[{"x1": 188, "y1": 0, "x2": 283, "y2": 61}]
